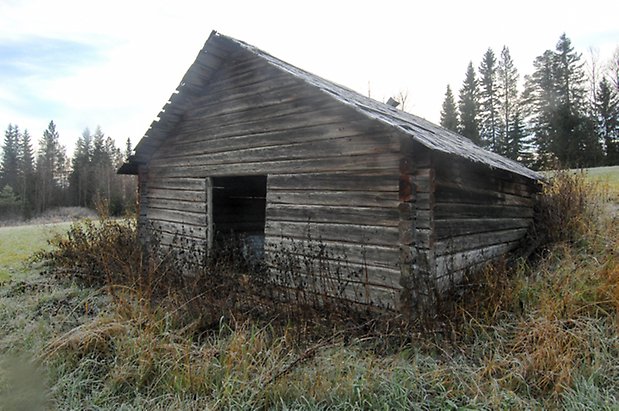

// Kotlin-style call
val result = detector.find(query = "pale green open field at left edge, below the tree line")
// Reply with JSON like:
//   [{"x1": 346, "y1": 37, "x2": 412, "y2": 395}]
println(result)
[{"x1": 0, "y1": 222, "x2": 71, "y2": 282}]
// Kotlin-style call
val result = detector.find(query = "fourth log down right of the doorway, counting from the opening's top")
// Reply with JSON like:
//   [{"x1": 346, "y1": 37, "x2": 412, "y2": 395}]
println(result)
[{"x1": 265, "y1": 221, "x2": 399, "y2": 247}]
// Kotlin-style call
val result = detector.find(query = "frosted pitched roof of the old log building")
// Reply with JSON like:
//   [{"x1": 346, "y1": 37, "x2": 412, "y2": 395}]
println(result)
[{"x1": 118, "y1": 31, "x2": 543, "y2": 180}]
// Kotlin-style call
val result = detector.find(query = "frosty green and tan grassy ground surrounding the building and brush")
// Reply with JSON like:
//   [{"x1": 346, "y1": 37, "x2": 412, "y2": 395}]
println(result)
[{"x1": 0, "y1": 167, "x2": 619, "y2": 411}]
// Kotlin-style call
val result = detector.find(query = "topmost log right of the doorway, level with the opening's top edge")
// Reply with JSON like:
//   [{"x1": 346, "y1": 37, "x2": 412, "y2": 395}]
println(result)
[{"x1": 268, "y1": 173, "x2": 398, "y2": 192}]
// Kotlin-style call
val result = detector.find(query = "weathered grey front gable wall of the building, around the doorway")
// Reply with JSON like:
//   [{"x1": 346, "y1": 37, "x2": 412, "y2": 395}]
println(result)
[{"x1": 141, "y1": 52, "x2": 402, "y2": 308}]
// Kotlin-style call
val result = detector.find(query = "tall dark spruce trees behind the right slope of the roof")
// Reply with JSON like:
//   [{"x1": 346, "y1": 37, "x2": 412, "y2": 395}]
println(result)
[{"x1": 440, "y1": 34, "x2": 619, "y2": 169}]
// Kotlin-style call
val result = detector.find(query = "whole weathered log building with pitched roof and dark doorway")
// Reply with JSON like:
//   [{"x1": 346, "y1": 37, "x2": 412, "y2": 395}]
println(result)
[{"x1": 119, "y1": 32, "x2": 540, "y2": 311}]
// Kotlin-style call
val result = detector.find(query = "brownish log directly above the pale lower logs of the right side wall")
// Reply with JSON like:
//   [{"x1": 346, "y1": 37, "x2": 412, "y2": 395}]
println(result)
[{"x1": 434, "y1": 218, "x2": 532, "y2": 240}]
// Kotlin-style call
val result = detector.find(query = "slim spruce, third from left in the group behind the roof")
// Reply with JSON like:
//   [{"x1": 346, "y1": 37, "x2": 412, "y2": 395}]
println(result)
[{"x1": 479, "y1": 48, "x2": 498, "y2": 154}]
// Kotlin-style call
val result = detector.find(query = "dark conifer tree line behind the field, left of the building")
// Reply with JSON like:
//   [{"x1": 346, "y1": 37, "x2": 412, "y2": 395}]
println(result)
[{"x1": 0, "y1": 121, "x2": 136, "y2": 219}]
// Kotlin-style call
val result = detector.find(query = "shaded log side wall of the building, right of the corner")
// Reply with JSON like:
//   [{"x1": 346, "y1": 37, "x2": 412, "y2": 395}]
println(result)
[{"x1": 432, "y1": 154, "x2": 536, "y2": 291}]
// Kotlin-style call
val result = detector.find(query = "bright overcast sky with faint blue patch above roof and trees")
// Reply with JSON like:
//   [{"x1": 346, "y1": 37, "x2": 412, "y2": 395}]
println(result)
[{"x1": 0, "y1": 0, "x2": 619, "y2": 152}]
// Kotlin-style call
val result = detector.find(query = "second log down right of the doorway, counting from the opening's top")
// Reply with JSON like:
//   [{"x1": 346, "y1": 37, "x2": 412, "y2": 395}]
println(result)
[{"x1": 267, "y1": 190, "x2": 399, "y2": 210}]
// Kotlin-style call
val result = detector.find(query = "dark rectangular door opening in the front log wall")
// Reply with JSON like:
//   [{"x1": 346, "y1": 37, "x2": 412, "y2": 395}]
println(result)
[{"x1": 211, "y1": 176, "x2": 267, "y2": 258}]
